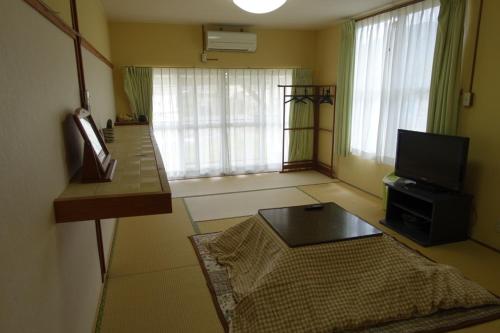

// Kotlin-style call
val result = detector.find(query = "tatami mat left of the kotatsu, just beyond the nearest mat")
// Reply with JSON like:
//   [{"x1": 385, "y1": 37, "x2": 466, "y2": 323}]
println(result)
[{"x1": 108, "y1": 199, "x2": 198, "y2": 277}]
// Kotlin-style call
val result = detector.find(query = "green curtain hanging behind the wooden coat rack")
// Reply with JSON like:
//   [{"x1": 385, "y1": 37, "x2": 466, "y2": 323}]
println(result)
[{"x1": 288, "y1": 69, "x2": 314, "y2": 162}]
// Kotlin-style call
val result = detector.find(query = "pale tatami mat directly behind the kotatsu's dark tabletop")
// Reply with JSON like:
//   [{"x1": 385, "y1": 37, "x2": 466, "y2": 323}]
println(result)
[{"x1": 184, "y1": 187, "x2": 317, "y2": 221}]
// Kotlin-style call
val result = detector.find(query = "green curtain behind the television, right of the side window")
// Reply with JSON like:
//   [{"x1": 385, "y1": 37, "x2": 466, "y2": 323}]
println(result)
[{"x1": 427, "y1": 0, "x2": 466, "y2": 135}]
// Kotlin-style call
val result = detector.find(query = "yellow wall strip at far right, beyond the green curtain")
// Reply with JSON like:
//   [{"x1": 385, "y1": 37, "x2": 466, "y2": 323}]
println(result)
[{"x1": 459, "y1": 0, "x2": 500, "y2": 249}]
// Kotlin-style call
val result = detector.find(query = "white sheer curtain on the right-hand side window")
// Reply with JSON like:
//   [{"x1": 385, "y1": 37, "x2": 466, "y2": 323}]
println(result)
[{"x1": 351, "y1": 0, "x2": 439, "y2": 164}]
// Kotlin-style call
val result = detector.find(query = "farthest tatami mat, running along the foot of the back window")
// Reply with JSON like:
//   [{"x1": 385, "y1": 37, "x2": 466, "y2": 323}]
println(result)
[{"x1": 169, "y1": 171, "x2": 337, "y2": 198}]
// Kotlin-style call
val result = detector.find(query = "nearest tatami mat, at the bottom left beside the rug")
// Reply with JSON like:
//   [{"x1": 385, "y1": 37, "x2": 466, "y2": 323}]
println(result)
[{"x1": 100, "y1": 266, "x2": 223, "y2": 333}]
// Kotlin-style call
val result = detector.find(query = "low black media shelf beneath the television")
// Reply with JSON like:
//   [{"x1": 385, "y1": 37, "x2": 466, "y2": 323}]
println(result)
[{"x1": 380, "y1": 183, "x2": 472, "y2": 246}]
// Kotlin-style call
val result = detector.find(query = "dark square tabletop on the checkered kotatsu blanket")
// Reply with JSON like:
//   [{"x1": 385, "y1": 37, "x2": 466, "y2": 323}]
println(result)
[{"x1": 259, "y1": 202, "x2": 382, "y2": 247}]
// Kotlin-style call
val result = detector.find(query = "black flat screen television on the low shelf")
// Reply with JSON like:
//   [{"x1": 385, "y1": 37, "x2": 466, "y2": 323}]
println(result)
[{"x1": 395, "y1": 129, "x2": 469, "y2": 191}]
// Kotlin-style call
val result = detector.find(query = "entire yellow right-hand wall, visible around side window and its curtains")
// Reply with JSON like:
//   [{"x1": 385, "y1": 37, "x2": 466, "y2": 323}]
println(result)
[{"x1": 316, "y1": 0, "x2": 500, "y2": 248}]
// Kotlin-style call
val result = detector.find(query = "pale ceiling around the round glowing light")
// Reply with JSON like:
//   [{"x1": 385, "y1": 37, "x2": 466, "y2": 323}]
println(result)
[{"x1": 102, "y1": 0, "x2": 401, "y2": 29}]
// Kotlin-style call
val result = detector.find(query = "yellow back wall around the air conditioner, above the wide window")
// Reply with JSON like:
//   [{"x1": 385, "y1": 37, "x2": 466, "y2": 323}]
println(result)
[{"x1": 110, "y1": 23, "x2": 316, "y2": 114}]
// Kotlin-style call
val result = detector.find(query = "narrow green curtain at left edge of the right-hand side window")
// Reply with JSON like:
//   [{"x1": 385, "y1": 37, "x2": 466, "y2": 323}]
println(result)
[{"x1": 335, "y1": 20, "x2": 356, "y2": 156}]
